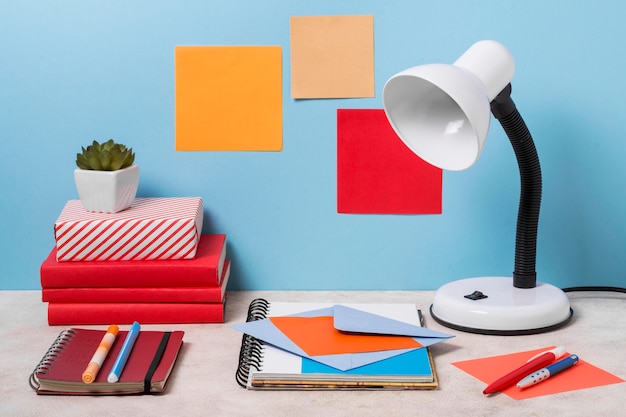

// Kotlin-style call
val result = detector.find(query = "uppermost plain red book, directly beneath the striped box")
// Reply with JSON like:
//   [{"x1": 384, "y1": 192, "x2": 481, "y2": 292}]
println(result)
[{"x1": 40, "y1": 234, "x2": 226, "y2": 288}]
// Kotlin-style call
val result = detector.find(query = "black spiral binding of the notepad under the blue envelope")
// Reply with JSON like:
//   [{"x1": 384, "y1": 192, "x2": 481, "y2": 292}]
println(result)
[{"x1": 235, "y1": 298, "x2": 270, "y2": 388}]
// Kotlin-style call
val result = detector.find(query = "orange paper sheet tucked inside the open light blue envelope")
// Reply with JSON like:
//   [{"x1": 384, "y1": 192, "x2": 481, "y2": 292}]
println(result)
[{"x1": 270, "y1": 316, "x2": 422, "y2": 356}]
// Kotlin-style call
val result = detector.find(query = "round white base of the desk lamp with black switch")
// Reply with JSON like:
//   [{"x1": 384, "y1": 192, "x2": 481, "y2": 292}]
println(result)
[{"x1": 430, "y1": 277, "x2": 574, "y2": 336}]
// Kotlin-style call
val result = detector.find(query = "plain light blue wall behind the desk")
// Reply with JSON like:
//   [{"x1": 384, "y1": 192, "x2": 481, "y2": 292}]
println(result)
[{"x1": 0, "y1": 0, "x2": 626, "y2": 289}]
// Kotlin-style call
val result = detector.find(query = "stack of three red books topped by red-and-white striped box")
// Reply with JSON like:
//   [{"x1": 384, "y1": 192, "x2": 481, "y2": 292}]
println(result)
[{"x1": 40, "y1": 199, "x2": 230, "y2": 325}]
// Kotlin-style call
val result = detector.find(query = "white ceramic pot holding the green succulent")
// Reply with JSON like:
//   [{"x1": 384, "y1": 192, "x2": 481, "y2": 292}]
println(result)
[{"x1": 74, "y1": 165, "x2": 139, "y2": 213}]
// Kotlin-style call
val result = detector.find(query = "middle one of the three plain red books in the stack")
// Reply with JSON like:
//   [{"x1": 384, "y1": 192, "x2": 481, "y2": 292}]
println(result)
[{"x1": 41, "y1": 259, "x2": 230, "y2": 303}]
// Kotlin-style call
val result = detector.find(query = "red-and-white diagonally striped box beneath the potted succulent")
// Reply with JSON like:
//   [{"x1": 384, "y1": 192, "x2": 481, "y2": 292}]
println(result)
[{"x1": 54, "y1": 197, "x2": 203, "y2": 262}]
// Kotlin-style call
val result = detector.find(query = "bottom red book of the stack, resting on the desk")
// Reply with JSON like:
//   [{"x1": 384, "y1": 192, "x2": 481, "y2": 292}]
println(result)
[{"x1": 48, "y1": 302, "x2": 226, "y2": 326}]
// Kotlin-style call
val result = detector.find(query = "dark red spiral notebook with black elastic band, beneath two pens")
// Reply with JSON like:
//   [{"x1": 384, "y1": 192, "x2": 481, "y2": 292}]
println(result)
[{"x1": 29, "y1": 328, "x2": 184, "y2": 395}]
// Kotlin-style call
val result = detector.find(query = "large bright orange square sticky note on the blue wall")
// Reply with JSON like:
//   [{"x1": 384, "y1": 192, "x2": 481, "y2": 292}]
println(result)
[{"x1": 175, "y1": 46, "x2": 282, "y2": 151}]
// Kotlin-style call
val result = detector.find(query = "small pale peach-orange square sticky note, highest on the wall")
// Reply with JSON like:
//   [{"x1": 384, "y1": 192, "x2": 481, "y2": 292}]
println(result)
[{"x1": 290, "y1": 15, "x2": 374, "y2": 99}]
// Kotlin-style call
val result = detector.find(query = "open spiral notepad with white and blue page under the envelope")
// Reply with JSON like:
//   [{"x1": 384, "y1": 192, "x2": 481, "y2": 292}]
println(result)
[{"x1": 235, "y1": 298, "x2": 438, "y2": 390}]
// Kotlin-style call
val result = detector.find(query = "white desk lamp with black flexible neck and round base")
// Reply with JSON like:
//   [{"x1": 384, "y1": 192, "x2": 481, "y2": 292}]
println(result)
[{"x1": 383, "y1": 41, "x2": 573, "y2": 335}]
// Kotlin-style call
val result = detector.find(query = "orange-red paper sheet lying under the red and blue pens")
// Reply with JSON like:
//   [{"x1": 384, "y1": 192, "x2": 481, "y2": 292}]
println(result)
[{"x1": 452, "y1": 346, "x2": 624, "y2": 400}]
